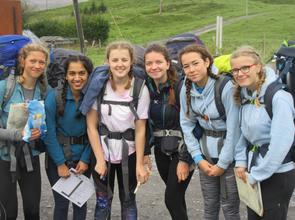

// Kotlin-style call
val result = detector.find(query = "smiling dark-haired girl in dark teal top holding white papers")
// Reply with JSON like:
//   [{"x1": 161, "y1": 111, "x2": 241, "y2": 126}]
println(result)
[{"x1": 45, "y1": 56, "x2": 93, "y2": 220}]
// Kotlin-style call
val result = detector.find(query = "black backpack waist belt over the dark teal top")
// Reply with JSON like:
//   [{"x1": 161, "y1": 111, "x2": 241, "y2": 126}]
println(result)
[{"x1": 57, "y1": 132, "x2": 89, "y2": 164}]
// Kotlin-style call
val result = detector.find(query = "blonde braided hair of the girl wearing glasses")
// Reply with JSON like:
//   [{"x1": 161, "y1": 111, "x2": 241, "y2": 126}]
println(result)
[{"x1": 230, "y1": 46, "x2": 266, "y2": 106}]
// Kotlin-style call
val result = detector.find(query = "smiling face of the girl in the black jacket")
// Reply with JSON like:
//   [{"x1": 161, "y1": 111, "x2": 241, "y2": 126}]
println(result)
[{"x1": 145, "y1": 51, "x2": 170, "y2": 83}]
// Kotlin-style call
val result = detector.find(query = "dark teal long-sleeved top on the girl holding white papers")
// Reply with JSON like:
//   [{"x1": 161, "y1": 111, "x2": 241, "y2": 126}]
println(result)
[{"x1": 45, "y1": 87, "x2": 91, "y2": 166}]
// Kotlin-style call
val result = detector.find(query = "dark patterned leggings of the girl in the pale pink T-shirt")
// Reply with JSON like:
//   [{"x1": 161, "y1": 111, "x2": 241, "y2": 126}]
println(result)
[{"x1": 92, "y1": 153, "x2": 137, "y2": 220}]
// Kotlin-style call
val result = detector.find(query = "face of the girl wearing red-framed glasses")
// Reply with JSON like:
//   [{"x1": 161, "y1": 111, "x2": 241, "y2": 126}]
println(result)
[{"x1": 231, "y1": 56, "x2": 262, "y2": 91}]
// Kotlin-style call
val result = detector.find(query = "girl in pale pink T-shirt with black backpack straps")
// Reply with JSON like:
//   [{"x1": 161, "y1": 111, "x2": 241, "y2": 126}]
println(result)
[{"x1": 87, "y1": 42, "x2": 149, "y2": 220}]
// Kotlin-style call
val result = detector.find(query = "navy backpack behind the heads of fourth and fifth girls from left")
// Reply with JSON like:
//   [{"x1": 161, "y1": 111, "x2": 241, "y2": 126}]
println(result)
[{"x1": 165, "y1": 33, "x2": 204, "y2": 72}]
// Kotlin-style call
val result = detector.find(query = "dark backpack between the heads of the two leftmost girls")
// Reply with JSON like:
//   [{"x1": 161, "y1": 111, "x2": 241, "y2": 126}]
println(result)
[{"x1": 46, "y1": 48, "x2": 83, "y2": 88}]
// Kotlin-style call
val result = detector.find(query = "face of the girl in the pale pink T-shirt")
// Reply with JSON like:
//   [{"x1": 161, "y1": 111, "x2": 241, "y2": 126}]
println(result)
[{"x1": 108, "y1": 49, "x2": 132, "y2": 79}]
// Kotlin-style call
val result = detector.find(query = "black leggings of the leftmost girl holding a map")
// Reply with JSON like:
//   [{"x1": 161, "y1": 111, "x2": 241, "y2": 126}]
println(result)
[{"x1": 0, "y1": 156, "x2": 41, "y2": 220}]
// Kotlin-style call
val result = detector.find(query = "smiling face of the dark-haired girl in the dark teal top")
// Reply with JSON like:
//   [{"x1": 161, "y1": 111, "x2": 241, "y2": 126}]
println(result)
[{"x1": 66, "y1": 62, "x2": 89, "y2": 92}]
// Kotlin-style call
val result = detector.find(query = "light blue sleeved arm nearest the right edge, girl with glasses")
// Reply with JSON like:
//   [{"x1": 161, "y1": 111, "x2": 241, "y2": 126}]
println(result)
[{"x1": 249, "y1": 90, "x2": 295, "y2": 184}]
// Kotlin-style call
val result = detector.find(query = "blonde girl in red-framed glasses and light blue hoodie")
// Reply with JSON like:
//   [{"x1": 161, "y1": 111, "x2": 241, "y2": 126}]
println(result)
[{"x1": 231, "y1": 46, "x2": 295, "y2": 220}]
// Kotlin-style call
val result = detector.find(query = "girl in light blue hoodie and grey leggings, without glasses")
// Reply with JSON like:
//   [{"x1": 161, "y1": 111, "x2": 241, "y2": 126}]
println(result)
[{"x1": 179, "y1": 45, "x2": 240, "y2": 219}]
